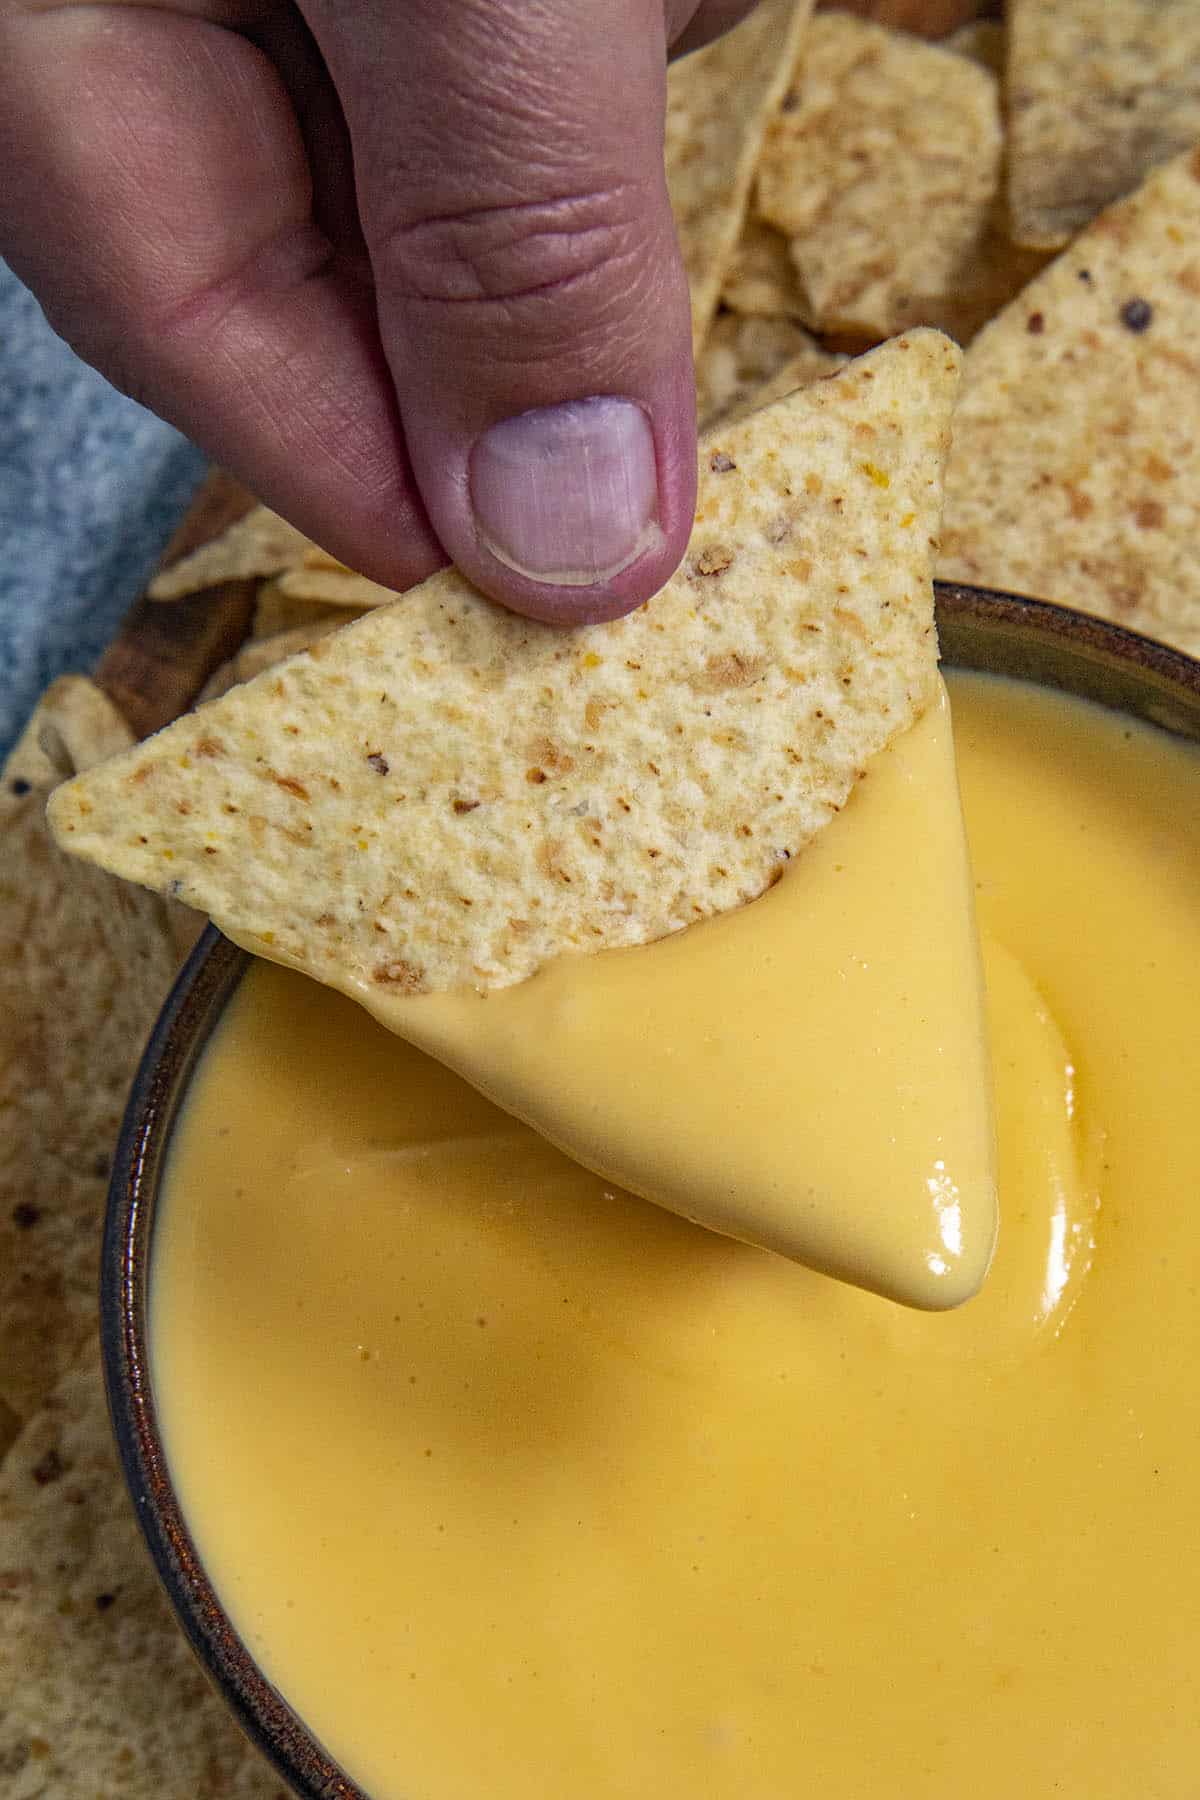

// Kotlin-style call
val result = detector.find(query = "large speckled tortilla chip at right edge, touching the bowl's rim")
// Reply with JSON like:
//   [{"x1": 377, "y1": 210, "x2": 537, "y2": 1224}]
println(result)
[{"x1": 937, "y1": 151, "x2": 1200, "y2": 655}]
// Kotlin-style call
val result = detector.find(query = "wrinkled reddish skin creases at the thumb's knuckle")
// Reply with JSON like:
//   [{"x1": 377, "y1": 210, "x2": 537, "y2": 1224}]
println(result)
[{"x1": 374, "y1": 184, "x2": 658, "y2": 325}]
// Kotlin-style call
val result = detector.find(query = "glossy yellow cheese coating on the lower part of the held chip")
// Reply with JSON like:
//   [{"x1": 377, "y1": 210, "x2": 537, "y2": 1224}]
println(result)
[{"x1": 371, "y1": 689, "x2": 997, "y2": 1309}]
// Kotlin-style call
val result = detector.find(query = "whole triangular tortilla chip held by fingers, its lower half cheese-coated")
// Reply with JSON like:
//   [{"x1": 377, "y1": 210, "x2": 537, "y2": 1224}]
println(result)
[{"x1": 52, "y1": 333, "x2": 995, "y2": 1307}]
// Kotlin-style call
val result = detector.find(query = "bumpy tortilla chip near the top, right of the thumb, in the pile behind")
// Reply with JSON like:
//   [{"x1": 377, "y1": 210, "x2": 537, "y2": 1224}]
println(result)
[{"x1": 757, "y1": 13, "x2": 1000, "y2": 337}]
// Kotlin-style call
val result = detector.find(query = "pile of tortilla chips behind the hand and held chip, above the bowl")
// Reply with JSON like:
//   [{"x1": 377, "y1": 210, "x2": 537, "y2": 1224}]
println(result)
[{"x1": 151, "y1": 0, "x2": 1200, "y2": 662}]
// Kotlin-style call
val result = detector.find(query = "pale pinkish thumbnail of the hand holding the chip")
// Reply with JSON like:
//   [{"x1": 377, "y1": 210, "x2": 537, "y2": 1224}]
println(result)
[{"x1": 471, "y1": 394, "x2": 662, "y2": 587}]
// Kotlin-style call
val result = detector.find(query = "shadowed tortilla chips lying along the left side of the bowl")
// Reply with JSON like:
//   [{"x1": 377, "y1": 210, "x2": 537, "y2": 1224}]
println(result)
[{"x1": 0, "y1": 677, "x2": 282, "y2": 1800}]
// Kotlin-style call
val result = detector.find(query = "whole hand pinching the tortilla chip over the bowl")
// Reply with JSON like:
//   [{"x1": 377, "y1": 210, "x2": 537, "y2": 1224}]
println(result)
[{"x1": 0, "y1": 0, "x2": 770, "y2": 619}]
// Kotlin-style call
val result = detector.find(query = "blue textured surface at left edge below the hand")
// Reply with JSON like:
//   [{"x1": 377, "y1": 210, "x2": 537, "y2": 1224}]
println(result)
[{"x1": 0, "y1": 263, "x2": 205, "y2": 756}]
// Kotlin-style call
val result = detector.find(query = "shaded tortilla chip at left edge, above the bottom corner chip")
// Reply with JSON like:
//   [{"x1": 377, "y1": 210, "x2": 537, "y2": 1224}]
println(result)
[{"x1": 0, "y1": 677, "x2": 176, "y2": 1417}]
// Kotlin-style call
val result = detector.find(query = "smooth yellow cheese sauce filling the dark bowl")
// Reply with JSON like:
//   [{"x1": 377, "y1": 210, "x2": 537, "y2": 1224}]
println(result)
[{"x1": 151, "y1": 677, "x2": 1200, "y2": 1800}]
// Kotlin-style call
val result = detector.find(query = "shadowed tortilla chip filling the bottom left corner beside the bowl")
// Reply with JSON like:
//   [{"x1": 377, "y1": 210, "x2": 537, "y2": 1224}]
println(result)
[{"x1": 0, "y1": 1343, "x2": 286, "y2": 1800}]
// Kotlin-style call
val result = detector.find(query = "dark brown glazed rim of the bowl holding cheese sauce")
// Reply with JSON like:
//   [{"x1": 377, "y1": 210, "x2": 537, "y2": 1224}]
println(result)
[{"x1": 101, "y1": 583, "x2": 1200, "y2": 1800}]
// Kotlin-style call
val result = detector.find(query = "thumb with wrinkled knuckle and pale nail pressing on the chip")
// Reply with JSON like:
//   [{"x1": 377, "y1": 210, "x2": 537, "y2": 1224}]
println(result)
[{"x1": 306, "y1": 0, "x2": 696, "y2": 621}]
